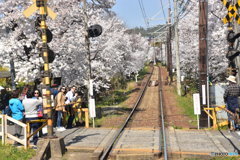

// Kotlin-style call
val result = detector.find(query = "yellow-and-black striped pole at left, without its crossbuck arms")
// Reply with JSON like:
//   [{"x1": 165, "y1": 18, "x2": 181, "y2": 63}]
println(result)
[{"x1": 38, "y1": 0, "x2": 53, "y2": 137}]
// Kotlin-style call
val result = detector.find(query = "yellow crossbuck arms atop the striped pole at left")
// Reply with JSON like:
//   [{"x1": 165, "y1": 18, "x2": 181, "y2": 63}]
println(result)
[{"x1": 23, "y1": 0, "x2": 57, "y2": 19}]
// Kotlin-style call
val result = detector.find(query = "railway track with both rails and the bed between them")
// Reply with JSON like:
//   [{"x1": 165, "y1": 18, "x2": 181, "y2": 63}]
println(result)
[{"x1": 100, "y1": 66, "x2": 167, "y2": 160}]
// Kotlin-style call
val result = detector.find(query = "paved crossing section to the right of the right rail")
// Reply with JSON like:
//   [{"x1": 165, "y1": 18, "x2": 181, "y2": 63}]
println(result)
[{"x1": 166, "y1": 128, "x2": 240, "y2": 159}]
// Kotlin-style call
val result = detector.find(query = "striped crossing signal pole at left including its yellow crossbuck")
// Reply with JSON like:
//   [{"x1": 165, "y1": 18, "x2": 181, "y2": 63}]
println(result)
[{"x1": 23, "y1": 0, "x2": 56, "y2": 138}]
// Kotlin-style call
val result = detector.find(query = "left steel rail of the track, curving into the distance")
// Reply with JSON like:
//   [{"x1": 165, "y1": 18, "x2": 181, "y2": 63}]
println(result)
[{"x1": 100, "y1": 66, "x2": 154, "y2": 160}]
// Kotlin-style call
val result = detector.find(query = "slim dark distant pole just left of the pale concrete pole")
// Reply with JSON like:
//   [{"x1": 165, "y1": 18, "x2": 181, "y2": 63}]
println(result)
[{"x1": 167, "y1": 0, "x2": 173, "y2": 83}]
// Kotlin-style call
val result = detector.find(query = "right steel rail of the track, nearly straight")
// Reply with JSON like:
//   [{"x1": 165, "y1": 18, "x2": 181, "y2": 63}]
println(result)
[{"x1": 158, "y1": 67, "x2": 168, "y2": 160}]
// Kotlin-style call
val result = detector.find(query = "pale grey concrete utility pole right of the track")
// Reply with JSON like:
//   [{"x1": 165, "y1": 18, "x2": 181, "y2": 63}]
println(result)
[{"x1": 174, "y1": 0, "x2": 181, "y2": 96}]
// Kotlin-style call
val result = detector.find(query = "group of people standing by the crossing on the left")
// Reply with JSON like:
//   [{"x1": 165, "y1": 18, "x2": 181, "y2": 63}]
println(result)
[{"x1": 0, "y1": 86, "x2": 81, "y2": 145}]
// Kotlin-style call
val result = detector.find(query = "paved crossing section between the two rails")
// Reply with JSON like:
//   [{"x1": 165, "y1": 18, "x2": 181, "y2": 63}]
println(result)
[{"x1": 110, "y1": 128, "x2": 161, "y2": 159}]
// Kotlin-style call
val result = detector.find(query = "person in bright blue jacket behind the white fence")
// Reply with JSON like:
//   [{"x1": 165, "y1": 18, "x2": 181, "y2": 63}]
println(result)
[{"x1": 9, "y1": 91, "x2": 24, "y2": 144}]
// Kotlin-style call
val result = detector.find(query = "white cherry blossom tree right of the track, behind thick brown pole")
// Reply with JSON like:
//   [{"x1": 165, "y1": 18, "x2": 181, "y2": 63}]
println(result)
[{"x1": 179, "y1": 0, "x2": 227, "y2": 81}]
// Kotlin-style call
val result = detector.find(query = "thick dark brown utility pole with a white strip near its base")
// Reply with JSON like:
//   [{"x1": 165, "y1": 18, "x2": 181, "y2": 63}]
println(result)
[{"x1": 199, "y1": 0, "x2": 208, "y2": 127}]
